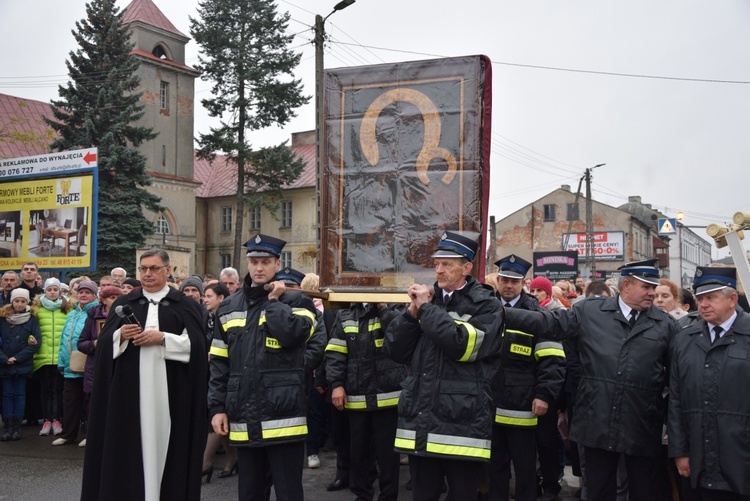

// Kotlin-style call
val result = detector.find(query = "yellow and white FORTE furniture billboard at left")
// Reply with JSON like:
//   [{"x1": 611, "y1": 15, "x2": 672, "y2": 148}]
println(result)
[{"x1": 0, "y1": 148, "x2": 98, "y2": 271}]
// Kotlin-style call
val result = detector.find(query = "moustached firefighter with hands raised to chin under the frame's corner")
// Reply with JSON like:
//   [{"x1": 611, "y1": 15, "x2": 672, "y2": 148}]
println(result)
[{"x1": 384, "y1": 232, "x2": 503, "y2": 500}]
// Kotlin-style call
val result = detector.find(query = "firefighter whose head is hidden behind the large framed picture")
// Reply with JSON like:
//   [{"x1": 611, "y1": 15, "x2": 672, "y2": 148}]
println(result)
[{"x1": 325, "y1": 303, "x2": 406, "y2": 500}]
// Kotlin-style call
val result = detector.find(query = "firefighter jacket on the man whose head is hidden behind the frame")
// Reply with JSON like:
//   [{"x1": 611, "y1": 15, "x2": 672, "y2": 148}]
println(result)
[{"x1": 325, "y1": 304, "x2": 406, "y2": 411}]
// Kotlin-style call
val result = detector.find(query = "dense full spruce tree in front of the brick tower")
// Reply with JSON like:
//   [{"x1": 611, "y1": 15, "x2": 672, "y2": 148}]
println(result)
[{"x1": 45, "y1": 0, "x2": 161, "y2": 275}]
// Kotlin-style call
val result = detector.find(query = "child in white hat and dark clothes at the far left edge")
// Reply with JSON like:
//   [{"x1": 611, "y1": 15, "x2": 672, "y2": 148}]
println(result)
[{"x1": 0, "y1": 288, "x2": 42, "y2": 442}]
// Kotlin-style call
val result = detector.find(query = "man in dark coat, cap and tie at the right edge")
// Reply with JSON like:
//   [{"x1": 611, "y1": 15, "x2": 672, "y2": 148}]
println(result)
[{"x1": 668, "y1": 267, "x2": 750, "y2": 500}]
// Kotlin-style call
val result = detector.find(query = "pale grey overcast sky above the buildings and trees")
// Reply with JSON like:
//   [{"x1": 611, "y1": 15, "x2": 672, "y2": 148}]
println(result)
[{"x1": 0, "y1": 0, "x2": 750, "y2": 253}]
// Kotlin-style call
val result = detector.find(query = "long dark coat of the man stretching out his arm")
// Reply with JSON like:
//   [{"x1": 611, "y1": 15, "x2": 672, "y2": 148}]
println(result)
[{"x1": 505, "y1": 296, "x2": 679, "y2": 457}]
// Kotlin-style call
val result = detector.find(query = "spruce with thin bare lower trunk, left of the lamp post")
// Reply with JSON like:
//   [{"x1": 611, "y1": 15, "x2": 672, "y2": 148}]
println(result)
[{"x1": 190, "y1": 0, "x2": 310, "y2": 266}]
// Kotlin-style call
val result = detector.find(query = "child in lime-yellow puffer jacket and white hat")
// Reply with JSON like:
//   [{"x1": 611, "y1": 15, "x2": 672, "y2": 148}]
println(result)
[{"x1": 31, "y1": 278, "x2": 73, "y2": 435}]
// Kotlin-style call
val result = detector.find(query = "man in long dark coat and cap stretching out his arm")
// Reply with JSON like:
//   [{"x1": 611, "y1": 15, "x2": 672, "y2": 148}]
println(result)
[{"x1": 505, "y1": 259, "x2": 679, "y2": 500}]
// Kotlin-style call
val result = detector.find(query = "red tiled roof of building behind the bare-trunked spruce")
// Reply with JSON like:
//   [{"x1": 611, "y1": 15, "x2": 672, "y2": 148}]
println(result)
[{"x1": 193, "y1": 144, "x2": 317, "y2": 198}]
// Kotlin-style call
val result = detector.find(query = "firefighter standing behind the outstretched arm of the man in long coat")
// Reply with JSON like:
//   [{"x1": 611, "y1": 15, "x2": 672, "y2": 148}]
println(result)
[{"x1": 489, "y1": 254, "x2": 565, "y2": 501}]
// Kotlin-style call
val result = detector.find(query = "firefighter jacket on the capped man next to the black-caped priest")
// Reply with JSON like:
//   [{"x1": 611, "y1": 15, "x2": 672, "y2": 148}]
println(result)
[{"x1": 208, "y1": 276, "x2": 326, "y2": 447}]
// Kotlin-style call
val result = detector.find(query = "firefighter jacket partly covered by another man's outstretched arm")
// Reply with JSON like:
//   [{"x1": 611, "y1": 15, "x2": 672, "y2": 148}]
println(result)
[{"x1": 492, "y1": 291, "x2": 565, "y2": 427}]
